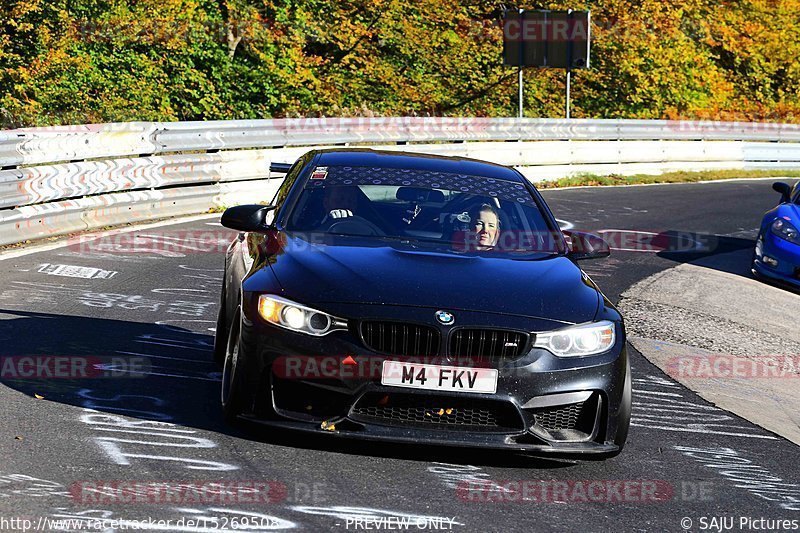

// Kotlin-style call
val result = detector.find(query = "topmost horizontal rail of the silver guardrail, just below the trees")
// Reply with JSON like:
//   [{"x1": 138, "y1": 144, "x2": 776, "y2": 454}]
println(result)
[{"x1": 0, "y1": 117, "x2": 800, "y2": 167}]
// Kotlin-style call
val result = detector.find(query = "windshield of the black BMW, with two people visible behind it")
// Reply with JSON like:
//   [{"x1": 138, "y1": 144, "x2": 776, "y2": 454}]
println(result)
[{"x1": 286, "y1": 166, "x2": 561, "y2": 253}]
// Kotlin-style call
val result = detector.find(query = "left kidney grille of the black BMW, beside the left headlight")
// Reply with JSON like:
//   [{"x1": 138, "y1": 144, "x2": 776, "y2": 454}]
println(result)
[{"x1": 361, "y1": 320, "x2": 440, "y2": 356}]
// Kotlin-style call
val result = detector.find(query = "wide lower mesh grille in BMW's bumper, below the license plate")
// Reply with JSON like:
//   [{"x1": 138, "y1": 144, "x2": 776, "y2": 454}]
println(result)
[{"x1": 350, "y1": 393, "x2": 523, "y2": 431}]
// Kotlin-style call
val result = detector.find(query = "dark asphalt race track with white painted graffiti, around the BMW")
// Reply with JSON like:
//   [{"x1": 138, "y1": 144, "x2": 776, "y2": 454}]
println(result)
[{"x1": 0, "y1": 180, "x2": 800, "y2": 531}]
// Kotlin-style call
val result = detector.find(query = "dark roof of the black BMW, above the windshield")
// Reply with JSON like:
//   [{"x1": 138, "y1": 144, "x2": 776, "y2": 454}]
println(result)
[{"x1": 316, "y1": 148, "x2": 525, "y2": 183}]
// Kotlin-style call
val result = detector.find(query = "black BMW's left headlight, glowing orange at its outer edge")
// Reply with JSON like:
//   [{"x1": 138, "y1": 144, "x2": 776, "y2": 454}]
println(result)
[{"x1": 258, "y1": 294, "x2": 347, "y2": 337}]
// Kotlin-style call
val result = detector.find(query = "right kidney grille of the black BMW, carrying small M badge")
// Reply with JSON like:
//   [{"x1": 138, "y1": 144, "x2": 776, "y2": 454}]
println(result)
[{"x1": 449, "y1": 329, "x2": 528, "y2": 363}]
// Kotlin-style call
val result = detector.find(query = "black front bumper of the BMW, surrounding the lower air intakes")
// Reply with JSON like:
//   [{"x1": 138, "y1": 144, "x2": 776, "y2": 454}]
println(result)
[{"x1": 242, "y1": 304, "x2": 630, "y2": 455}]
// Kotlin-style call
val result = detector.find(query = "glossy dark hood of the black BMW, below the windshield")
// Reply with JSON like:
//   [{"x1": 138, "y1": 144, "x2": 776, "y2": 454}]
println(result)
[{"x1": 268, "y1": 234, "x2": 601, "y2": 324}]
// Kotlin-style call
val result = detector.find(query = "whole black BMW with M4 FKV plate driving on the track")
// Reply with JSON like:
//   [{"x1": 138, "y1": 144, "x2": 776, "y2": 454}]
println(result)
[{"x1": 214, "y1": 149, "x2": 631, "y2": 457}]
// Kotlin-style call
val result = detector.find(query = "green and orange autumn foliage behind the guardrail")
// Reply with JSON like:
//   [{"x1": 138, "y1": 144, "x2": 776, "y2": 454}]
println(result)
[{"x1": 0, "y1": 0, "x2": 800, "y2": 128}]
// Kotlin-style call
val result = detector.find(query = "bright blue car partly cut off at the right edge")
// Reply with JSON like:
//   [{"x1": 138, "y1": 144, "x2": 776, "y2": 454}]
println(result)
[{"x1": 753, "y1": 181, "x2": 800, "y2": 289}]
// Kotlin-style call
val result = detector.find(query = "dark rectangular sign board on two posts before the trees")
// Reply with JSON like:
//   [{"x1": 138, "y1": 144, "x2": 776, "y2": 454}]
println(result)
[{"x1": 503, "y1": 9, "x2": 591, "y2": 70}]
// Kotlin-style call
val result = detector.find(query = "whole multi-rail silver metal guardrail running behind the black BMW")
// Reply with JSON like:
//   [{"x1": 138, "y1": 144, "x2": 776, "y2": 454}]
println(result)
[{"x1": 0, "y1": 117, "x2": 800, "y2": 244}]
